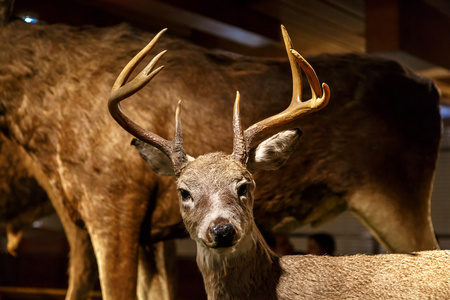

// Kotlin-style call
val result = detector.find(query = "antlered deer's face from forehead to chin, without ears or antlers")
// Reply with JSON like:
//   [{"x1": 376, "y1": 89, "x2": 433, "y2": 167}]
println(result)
[{"x1": 177, "y1": 153, "x2": 255, "y2": 251}]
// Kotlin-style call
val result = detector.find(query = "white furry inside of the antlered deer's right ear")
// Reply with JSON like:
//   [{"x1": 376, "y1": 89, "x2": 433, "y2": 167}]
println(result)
[{"x1": 255, "y1": 130, "x2": 298, "y2": 163}]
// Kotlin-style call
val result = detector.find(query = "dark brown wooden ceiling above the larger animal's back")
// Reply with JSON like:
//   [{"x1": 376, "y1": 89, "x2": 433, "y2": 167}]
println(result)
[{"x1": 10, "y1": 0, "x2": 450, "y2": 105}]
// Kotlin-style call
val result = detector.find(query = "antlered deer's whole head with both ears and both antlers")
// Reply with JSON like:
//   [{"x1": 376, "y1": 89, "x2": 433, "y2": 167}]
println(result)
[{"x1": 109, "y1": 26, "x2": 330, "y2": 252}]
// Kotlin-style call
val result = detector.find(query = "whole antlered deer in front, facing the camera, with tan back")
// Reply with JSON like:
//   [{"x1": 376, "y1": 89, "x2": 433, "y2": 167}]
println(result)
[{"x1": 108, "y1": 26, "x2": 450, "y2": 300}]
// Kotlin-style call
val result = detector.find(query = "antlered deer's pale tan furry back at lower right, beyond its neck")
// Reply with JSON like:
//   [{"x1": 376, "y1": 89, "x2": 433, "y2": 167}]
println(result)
[{"x1": 277, "y1": 251, "x2": 450, "y2": 300}]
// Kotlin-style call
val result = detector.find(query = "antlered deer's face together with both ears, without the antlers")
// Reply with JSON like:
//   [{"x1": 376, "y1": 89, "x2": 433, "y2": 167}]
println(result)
[{"x1": 133, "y1": 130, "x2": 301, "y2": 253}]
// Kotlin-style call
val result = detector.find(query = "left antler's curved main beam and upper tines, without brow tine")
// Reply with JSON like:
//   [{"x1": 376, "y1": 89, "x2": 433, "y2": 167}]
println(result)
[{"x1": 108, "y1": 29, "x2": 181, "y2": 157}]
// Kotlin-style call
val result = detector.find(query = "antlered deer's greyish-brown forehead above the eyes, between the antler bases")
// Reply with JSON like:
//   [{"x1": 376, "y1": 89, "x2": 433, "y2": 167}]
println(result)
[{"x1": 177, "y1": 152, "x2": 253, "y2": 191}]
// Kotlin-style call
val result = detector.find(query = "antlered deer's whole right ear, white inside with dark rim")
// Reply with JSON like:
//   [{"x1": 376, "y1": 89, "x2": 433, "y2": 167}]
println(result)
[{"x1": 247, "y1": 129, "x2": 303, "y2": 173}]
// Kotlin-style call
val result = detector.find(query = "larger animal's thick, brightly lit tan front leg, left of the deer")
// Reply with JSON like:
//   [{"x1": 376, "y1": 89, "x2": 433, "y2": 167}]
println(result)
[{"x1": 83, "y1": 197, "x2": 145, "y2": 300}]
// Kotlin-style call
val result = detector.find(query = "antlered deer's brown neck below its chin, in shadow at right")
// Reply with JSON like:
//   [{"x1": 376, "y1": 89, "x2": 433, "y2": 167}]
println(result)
[{"x1": 197, "y1": 224, "x2": 280, "y2": 300}]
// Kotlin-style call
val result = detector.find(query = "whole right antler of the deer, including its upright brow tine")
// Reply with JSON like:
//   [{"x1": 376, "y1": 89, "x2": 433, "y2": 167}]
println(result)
[{"x1": 233, "y1": 25, "x2": 330, "y2": 164}]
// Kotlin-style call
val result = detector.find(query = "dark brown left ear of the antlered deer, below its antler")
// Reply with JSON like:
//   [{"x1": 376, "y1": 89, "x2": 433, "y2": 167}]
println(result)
[{"x1": 131, "y1": 139, "x2": 175, "y2": 176}]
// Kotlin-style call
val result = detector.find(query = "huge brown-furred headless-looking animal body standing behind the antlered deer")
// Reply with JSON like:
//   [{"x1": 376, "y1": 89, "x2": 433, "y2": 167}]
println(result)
[{"x1": 0, "y1": 22, "x2": 440, "y2": 299}]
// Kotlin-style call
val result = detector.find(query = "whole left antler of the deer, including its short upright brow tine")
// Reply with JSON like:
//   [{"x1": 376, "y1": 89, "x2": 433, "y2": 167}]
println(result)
[{"x1": 108, "y1": 29, "x2": 187, "y2": 173}]
